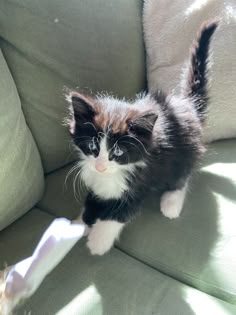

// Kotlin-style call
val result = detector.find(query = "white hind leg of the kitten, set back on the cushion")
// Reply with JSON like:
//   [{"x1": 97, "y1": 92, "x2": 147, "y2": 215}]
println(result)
[{"x1": 160, "y1": 181, "x2": 188, "y2": 219}]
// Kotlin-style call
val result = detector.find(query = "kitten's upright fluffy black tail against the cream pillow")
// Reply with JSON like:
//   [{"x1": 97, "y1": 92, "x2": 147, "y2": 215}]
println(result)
[{"x1": 182, "y1": 18, "x2": 220, "y2": 122}]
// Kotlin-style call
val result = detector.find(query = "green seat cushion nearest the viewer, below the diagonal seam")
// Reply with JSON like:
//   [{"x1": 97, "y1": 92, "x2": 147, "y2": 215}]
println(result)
[{"x1": 0, "y1": 209, "x2": 236, "y2": 315}]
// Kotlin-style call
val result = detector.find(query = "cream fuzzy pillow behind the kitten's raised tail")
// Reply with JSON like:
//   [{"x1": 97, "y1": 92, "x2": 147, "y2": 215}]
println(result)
[{"x1": 143, "y1": 0, "x2": 236, "y2": 142}]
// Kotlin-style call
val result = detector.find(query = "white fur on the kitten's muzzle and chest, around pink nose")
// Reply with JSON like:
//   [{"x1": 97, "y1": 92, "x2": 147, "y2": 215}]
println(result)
[{"x1": 80, "y1": 137, "x2": 145, "y2": 199}]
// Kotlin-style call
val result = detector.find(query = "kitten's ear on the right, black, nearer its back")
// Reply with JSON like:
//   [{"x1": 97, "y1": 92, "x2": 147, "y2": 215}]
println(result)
[{"x1": 128, "y1": 112, "x2": 158, "y2": 136}]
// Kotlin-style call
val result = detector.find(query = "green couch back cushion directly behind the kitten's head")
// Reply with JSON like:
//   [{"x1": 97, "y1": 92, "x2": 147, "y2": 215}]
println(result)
[{"x1": 0, "y1": 0, "x2": 145, "y2": 172}]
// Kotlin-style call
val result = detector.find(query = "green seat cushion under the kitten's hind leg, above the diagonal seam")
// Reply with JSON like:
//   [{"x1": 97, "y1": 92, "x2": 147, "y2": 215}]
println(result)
[{"x1": 40, "y1": 140, "x2": 236, "y2": 304}]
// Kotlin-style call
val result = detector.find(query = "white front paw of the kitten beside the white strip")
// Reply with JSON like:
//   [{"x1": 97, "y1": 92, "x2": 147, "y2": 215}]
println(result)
[{"x1": 87, "y1": 220, "x2": 124, "y2": 255}]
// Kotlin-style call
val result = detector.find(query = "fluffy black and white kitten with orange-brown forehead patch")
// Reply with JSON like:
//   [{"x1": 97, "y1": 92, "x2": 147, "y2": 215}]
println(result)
[{"x1": 69, "y1": 20, "x2": 218, "y2": 255}]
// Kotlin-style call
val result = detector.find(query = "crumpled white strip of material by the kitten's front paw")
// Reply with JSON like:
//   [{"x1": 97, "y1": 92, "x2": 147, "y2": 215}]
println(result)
[{"x1": 2, "y1": 218, "x2": 86, "y2": 314}]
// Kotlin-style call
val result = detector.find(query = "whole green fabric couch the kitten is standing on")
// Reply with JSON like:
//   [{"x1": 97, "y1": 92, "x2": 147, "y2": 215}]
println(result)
[{"x1": 0, "y1": 0, "x2": 236, "y2": 315}]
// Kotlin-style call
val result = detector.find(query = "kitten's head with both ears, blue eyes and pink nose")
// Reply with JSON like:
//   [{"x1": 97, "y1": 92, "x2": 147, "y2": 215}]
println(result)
[{"x1": 70, "y1": 93, "x2": 157, "y2": 174}]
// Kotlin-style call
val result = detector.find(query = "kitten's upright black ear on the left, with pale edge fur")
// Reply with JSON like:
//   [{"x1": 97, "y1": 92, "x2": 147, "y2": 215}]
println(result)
[{"x1": 68, "y1": 92, "x2": 96, "y2": 134}]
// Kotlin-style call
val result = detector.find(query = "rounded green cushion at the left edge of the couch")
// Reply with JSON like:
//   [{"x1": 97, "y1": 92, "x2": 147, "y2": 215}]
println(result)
[{"x1": 0, "y1": 51, "x2": 44, "y2": 230}]
